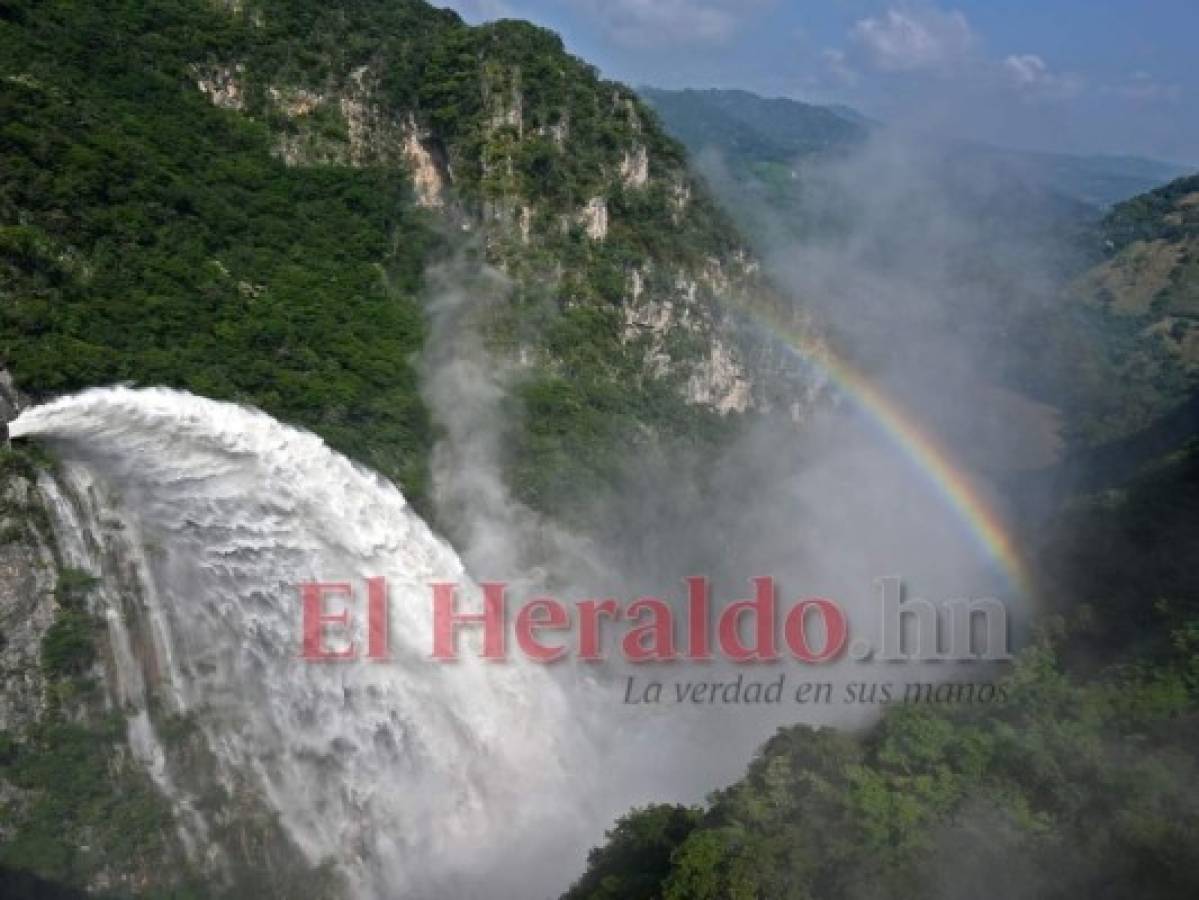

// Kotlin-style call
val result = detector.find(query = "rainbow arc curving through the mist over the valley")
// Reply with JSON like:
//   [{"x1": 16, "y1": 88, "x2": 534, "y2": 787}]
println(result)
[{"x1": 751, "y1": 310, "x2": 1032, "y2": 596}]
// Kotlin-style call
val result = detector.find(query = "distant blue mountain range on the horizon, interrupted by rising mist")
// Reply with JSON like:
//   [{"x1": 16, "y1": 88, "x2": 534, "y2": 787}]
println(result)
[{"x1": 639, "y1": 87, "x2": 1188, "y2": 209}]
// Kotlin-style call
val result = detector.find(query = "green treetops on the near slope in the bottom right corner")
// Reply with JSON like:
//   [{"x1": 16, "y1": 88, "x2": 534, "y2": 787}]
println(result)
[{"x1": 567, "y1": 650, "x2": 1199, "y2": 900}]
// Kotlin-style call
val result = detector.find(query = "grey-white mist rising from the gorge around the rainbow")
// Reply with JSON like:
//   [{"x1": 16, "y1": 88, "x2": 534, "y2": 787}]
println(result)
[{"x1": 402, "y1": 123, "x2": 1088, "y2": 892}]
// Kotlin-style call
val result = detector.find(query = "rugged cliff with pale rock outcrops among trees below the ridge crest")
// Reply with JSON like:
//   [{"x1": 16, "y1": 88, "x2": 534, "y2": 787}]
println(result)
[{"x1": 193, "y1": 1, "x2": 811, "y2": 413}]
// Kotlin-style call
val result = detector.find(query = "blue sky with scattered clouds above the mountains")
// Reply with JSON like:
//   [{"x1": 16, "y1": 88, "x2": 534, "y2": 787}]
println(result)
[{"x1": 440, "y1": 0, "x2": 1199, "y2": 165}]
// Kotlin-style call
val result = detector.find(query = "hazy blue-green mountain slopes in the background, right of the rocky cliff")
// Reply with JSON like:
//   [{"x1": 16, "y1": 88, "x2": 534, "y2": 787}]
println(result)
[{"x1": 647, "y1": 84, "x2": 1197, "y2": 448}]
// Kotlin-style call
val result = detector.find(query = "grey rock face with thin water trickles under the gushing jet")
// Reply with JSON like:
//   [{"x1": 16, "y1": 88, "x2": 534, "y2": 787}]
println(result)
[{"x1": 0, "y1": 370, "x2": 328, "y2": 898}]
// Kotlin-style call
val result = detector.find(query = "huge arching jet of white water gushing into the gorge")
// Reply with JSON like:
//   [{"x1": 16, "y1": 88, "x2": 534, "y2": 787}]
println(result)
[{"x1": 11, "y1": 388, "x2": 594, "y2": 898}]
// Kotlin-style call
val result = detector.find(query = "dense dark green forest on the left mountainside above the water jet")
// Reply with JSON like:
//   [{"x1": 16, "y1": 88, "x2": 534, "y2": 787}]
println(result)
[{"x1": 0, "y1": 2, "x2": 430, "y2": 495}]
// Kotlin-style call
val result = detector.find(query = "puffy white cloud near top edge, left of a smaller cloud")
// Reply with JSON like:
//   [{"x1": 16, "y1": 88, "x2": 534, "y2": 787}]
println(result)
[{"x1": 850, "y1": 6, "x2": 976, "y2": 72}]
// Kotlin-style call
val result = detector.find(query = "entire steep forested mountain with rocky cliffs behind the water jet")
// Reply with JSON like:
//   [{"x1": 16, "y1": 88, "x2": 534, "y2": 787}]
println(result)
[{"x1": 0, "y1": 0, "x2": 820, "y2": 517}]
